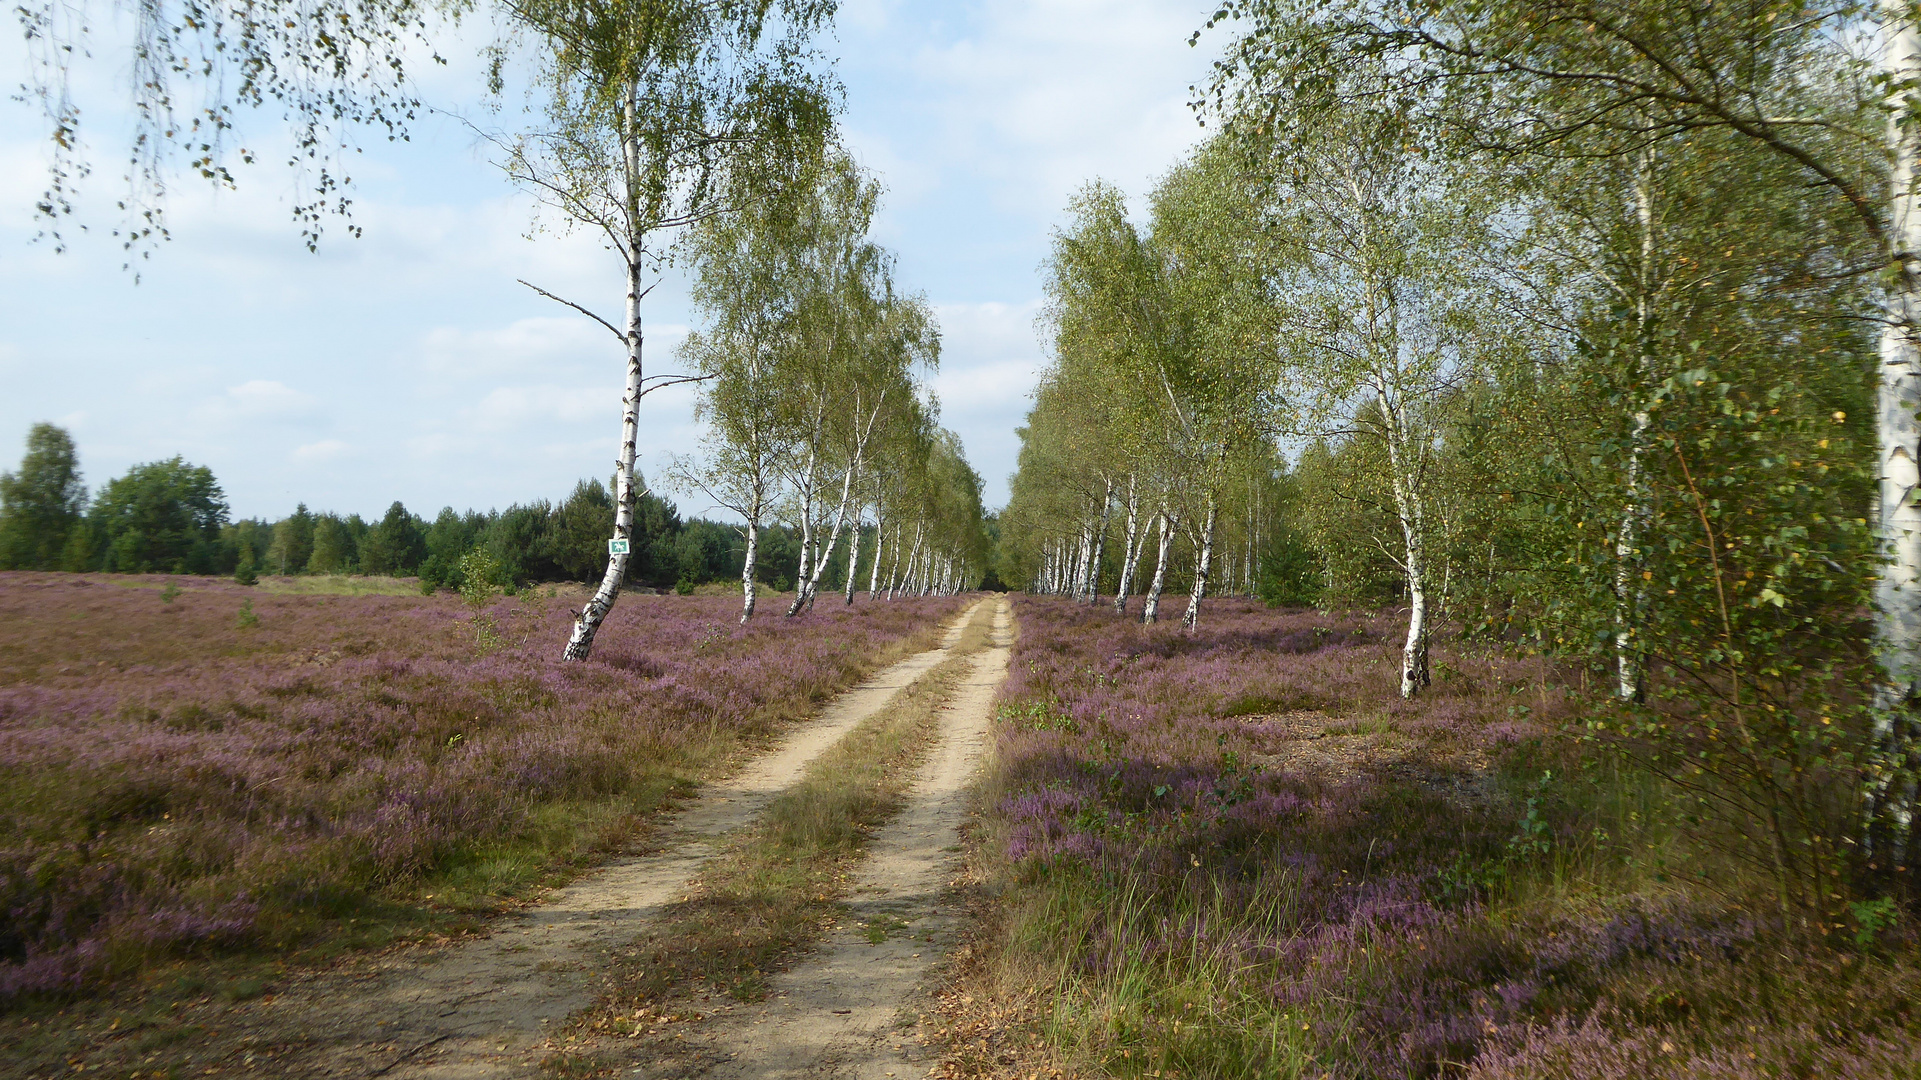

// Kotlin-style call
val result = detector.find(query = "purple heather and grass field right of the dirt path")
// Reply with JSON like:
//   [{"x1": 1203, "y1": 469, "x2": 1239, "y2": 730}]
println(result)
[{"x1": 985, "y1": 598, "x2": 1921, "y2": 1080}]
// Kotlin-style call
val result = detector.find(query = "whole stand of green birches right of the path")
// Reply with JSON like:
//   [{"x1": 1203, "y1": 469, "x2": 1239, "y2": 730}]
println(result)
[{"x1": 1003, "y1": 0, "x2": 1921, "y2": 899}]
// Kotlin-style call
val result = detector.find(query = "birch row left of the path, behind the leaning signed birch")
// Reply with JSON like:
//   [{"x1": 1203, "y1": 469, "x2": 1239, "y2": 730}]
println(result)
[{"x1": 674, "y1": 152, "x2": 985, "y2": 621}]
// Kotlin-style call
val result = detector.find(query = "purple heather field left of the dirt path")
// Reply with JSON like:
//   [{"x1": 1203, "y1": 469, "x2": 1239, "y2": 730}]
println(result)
[{"x1": 0, "y1": 573, "x2": 961, "y2": 999}]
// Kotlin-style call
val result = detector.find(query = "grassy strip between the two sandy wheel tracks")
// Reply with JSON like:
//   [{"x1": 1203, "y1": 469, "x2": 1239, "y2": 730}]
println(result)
[{"x1": 553, "y1": 601, "x2": 995, "y2": 1053}]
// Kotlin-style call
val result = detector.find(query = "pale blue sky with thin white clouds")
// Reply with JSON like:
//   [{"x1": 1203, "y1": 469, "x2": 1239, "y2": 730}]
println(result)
[{"x1": 0, "y1": 0, "x2": 1220, "y2": 517}]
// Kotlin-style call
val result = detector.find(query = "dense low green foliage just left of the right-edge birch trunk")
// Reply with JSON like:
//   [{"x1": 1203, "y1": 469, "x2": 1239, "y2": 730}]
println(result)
[{"x1": 1582, "y1": 357, "x2": 1877, "y2": 914}]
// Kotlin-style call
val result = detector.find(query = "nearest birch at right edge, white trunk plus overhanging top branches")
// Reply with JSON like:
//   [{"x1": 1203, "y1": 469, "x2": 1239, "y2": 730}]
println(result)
[{"x1": 1210, "y1": 0, "x2": 1921, "y2": 847}]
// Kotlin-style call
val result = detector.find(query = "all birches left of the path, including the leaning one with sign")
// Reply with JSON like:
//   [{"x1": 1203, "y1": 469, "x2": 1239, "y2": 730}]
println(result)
[{"x1": 468, "y1": 0, "x2": 985, "y2": 645}]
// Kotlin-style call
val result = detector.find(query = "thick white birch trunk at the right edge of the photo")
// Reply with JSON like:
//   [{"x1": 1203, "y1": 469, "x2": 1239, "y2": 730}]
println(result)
[{"x1": 1867, "y1": 0, "x2": 1921, "y2": 861}]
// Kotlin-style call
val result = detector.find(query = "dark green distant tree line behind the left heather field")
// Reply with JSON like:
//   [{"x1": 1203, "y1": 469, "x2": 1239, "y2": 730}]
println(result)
[{"x1": 0, "y1": 423, "x2": 868, "y2": 592}]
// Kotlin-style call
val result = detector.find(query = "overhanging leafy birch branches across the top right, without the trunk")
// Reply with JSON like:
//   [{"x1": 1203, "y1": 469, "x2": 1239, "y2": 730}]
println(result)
[{"x1": 1208, "y1": 0, "x2": 1882, "y2": 269}]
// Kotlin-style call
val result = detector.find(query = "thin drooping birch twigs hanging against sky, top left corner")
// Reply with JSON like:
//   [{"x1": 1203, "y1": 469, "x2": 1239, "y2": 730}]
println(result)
[{"x1": 13, "y1": 0, "x2": 471, "y2": 254}]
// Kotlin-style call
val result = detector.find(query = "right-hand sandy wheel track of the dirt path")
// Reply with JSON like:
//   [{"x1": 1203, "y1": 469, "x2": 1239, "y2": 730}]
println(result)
[{"x1": 624, "y1": 600, "x2": 1012, "y2": 1080}]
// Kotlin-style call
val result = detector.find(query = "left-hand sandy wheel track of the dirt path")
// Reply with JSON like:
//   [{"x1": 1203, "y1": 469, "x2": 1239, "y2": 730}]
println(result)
[{"x1": 240, "y1": 609, "x2": 972, "y2": 1080}]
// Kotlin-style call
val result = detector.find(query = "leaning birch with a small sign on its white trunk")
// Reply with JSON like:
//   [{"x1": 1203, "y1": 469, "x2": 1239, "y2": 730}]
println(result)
[{"x1": 494, "y1": 0, "x2": 834, "y2": 659}]
